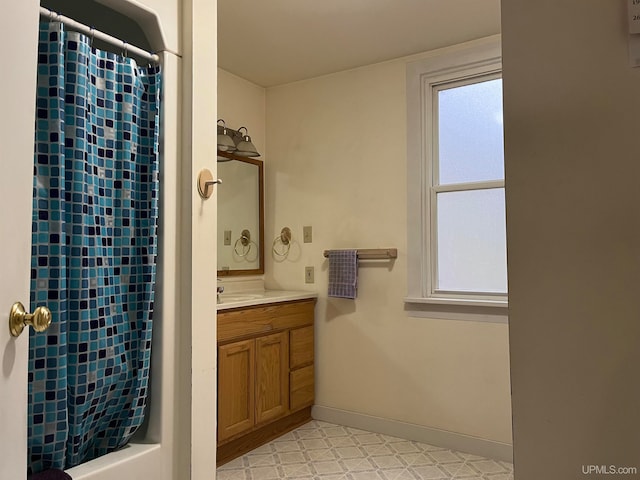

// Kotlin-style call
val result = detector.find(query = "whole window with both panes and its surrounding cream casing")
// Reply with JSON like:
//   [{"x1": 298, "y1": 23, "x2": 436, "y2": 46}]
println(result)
[{"x1": 406, "y1": 39, "x2": 507, "y2": 316}]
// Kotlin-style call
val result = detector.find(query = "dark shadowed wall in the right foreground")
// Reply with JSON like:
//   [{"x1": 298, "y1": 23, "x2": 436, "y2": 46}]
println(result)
[{"x1": 502, "y1": 0, "x2": 640, "y2": 480}]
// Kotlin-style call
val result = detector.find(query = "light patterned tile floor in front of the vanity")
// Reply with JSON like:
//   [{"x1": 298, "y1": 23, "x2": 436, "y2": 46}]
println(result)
[{"x1": 217, "y1": 420, "x2": 513, "y2": 480}]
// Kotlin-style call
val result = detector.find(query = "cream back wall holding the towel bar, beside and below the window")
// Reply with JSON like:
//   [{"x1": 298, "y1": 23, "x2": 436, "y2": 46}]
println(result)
[{"x1": 265, "y1": 57, "x2": 511, "y2": 443}]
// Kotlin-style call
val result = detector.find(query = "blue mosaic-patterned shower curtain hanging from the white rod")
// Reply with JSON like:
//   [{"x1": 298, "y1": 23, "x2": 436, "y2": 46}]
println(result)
[{"x1": 28, "y1": 23, "x2": 161, "y2": 473}]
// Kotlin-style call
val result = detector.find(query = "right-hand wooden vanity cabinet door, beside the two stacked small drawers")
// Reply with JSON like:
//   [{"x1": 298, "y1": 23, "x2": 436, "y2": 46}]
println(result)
[{"x1": 256, "y1": 332, "x2": 289, "y2": 423}]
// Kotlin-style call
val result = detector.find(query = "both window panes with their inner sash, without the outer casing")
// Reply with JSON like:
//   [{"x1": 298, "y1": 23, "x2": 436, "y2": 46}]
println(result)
[{"x1": 428, "y1": 75, "x2": 507, "y2": 296}]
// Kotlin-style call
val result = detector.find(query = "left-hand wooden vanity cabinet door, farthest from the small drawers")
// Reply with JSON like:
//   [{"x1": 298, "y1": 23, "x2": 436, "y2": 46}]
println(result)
[{"x1": 218, "y1": 340, "x2": 255, "y2": 441}]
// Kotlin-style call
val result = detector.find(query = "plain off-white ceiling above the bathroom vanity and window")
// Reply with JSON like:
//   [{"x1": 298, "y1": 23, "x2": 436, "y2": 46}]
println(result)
[{"x1": 218, "y1": 0, "x2": 500, "y2": 87}]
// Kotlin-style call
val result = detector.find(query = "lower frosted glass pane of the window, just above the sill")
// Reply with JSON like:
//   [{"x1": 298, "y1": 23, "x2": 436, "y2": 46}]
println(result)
[{"x1": 436, "y1": 188, "x2": 507, "y2": 293}]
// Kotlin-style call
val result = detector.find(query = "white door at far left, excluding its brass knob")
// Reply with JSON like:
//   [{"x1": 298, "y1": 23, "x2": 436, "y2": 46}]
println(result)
[{"x1": 0, "y1": 0, "x2": 39, "y2": 480}]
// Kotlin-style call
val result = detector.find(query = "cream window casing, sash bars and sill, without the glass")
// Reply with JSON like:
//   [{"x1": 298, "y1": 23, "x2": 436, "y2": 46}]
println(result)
[{"x1": 405, "y1": 36, "x2": 508, "y2": 322}]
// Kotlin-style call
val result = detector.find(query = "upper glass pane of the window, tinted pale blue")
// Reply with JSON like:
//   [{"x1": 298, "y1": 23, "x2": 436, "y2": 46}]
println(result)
[{"x1": 438, "y1": 79, "x2": 504, "y2": 185}]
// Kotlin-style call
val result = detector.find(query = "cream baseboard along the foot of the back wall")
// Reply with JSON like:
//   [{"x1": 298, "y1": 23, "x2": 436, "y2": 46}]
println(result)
[{"x1": 311, "y1": 405, "x2": 513, "y2": 463}]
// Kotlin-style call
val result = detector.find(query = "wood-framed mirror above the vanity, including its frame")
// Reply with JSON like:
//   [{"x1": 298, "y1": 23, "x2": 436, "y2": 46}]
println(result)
[{"x1": 217, "y1": 151, "x2": 264, "y2": 276}]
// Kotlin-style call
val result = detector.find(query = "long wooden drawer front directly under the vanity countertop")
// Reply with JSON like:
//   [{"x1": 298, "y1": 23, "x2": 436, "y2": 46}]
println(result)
[{"x1": 217, "y1": 299, "x2": 315, "y2": 344}]
